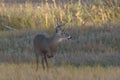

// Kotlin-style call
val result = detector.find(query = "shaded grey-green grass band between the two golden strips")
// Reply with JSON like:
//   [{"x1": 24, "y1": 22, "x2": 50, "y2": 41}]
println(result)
[{"x1": 0, "y1": 24, "x2": 120, "y2": 66}]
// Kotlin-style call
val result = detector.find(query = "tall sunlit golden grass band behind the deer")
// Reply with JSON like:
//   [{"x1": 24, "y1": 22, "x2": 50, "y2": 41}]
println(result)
[{"x1": 0, "y1": 0, "x2": 120, "y2": 29}]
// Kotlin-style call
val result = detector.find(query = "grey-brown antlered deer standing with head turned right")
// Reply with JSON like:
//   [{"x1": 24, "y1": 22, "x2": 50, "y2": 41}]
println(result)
[{"x1": 33, "y1": 24, "x2": 72, "y2": 71}]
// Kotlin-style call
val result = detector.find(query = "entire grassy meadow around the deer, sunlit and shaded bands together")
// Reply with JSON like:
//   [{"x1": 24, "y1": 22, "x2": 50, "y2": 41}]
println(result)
[{"x1": 0, "y1": 0, "x2": 120, "y2": 80}]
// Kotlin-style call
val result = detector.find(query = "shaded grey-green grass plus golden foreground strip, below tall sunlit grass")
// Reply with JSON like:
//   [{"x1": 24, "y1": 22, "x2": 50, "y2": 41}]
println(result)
[{"x1": 0, "y1": 24, "x2": 120, "y2": 80}]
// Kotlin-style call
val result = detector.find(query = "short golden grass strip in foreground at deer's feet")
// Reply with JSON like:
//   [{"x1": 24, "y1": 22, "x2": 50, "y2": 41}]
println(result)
[{"x1": 0, "y1": 64, "x2": 120, "y2": 80}]
